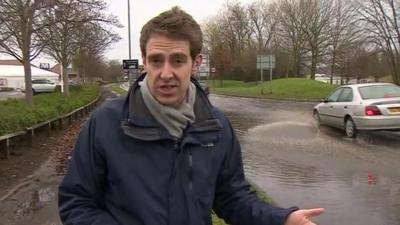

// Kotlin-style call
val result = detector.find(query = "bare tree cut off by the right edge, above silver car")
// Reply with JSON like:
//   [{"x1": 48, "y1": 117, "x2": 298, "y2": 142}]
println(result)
[{"x1": 357, "y1": 0, "x2": 400, "y2": 84}]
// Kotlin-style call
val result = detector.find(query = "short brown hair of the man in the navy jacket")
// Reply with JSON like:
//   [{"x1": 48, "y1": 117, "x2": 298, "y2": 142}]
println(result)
[{"x1": 140, "y1": 6, "x2": 203, "y2": 60}]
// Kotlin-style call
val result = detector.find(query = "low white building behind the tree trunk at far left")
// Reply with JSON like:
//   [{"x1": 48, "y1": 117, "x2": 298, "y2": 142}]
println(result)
[{"x1": 0, "y1": 60, "x2": 60, "y2": 89}]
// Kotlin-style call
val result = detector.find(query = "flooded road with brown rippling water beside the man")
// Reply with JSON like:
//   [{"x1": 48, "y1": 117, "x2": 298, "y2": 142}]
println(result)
[{"x1": 210, "y1": 95, "x2": 400, "y2": 225}]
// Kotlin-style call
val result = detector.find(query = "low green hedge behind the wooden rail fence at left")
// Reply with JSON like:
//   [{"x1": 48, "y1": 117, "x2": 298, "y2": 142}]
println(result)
[{"x1": 0, "y1": 85, "x2": 99, "y2": 136}]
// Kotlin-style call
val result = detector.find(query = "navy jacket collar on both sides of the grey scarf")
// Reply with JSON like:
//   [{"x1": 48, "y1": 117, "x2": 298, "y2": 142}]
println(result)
[{"x1": 121, "y1": 74, "x2": 222, "y2": 144}]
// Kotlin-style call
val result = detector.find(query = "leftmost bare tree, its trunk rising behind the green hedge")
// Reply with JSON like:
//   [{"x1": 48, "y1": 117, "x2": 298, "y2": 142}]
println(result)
[{"x1": 0, "y1": 0, "x2": 54, "y2": 105}]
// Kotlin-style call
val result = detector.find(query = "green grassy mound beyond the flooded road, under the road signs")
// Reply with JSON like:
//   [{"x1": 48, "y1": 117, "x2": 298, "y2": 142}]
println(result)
[{"x1": 209, "y1": 78, "x2": 337, "y2": 101}]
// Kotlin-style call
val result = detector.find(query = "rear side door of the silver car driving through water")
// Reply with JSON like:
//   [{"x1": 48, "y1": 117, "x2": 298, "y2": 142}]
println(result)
[{"x1": 331, "y1": 87, "x2": 353, "y2": 128}]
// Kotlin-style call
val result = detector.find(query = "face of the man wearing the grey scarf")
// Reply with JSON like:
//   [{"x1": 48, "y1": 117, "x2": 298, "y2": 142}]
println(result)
[{"x1": 143, "y1": 35, "x2": 201, "y2": 107}]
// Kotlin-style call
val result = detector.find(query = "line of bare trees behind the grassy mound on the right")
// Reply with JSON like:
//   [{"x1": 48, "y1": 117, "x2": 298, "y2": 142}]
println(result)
[{"x1": 203, "y1": 0, "x2": 400, "y2": 84}]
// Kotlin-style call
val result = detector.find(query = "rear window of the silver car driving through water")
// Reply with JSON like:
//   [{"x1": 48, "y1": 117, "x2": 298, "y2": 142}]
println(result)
[{"x1": 358, "y1": 85, "x2": 400, "y2": 100}]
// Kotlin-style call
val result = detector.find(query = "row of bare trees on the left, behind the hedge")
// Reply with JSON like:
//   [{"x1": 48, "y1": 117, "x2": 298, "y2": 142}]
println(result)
[{"x1": 0, "y1": 0, "x2": 121, "y2": 105}]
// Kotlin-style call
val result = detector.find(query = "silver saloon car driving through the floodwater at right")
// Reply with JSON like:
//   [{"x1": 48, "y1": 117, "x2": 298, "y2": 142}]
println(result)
[{"x1": 314, "y1": 83, "x2": 400, "y2": 138}]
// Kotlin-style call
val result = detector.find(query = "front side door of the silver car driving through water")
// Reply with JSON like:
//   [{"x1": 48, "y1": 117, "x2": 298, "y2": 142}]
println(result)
[{"x1": 318, "y1": 88, "x2": 343, "y2": 126}]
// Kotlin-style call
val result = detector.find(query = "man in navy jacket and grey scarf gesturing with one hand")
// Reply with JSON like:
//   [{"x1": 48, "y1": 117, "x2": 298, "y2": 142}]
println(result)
[{"x1": 59, "y1": 7, "x2": 323, "y2": 225}]
